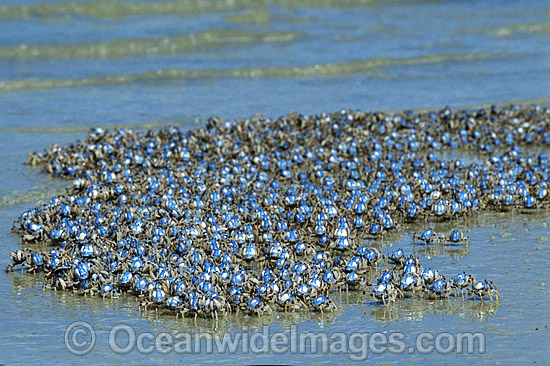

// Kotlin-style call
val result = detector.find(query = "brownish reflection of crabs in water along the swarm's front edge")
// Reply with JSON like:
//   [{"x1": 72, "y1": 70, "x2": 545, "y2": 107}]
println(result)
[{"x1": 9, "y1": 237, "x2": 499, "y2": 334}]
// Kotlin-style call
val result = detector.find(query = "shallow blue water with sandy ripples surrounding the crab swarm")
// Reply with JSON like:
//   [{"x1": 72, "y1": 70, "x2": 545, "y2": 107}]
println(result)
[{"x1": 0, "y1": 0, "x2": 550, "y2": 364}]
